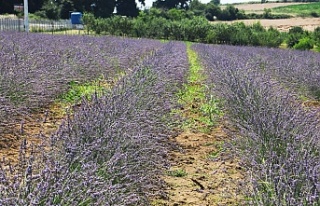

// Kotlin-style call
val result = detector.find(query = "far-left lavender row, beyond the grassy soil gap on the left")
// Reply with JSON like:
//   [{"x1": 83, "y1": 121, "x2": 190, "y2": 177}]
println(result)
[{"x1": 0, "y1": 32, "x2": 162, "y2": 132}]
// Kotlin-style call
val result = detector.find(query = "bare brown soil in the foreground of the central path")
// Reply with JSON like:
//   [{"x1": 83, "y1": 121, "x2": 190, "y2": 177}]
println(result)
[{"x1": 153, "y1": 126, "x2": 245, "y2": 206}]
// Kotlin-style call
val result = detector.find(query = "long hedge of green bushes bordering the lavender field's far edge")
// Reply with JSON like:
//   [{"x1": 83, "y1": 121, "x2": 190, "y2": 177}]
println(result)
[{"x1": 83, "y1": 8, "x2": 320, "y2": 51}]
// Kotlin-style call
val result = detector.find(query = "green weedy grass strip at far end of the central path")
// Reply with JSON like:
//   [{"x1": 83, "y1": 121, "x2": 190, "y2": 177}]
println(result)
[{"x1": 178, "y1": 43, "x2": 222, "y2": 132}]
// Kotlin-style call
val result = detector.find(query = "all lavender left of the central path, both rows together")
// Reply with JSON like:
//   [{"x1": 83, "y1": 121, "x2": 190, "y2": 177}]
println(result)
[{"x1": 0, "y1": 33, "x2": 188, "y2": 205}]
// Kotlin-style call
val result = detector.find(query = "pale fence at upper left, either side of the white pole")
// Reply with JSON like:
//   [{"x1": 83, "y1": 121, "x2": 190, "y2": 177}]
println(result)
[{"x1": 0, "y1": 17, "x2": 83, "y2": 32}]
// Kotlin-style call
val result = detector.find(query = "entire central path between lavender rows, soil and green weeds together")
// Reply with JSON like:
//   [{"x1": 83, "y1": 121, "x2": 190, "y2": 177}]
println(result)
[{"x1": 152, "y1": 43, "x2": 242, "y2": 206}]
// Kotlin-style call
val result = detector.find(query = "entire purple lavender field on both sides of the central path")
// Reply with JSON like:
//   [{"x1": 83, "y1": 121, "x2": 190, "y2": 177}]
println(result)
[{"x1": 0, "y1": 33, "x2": 320, "y2": 205}]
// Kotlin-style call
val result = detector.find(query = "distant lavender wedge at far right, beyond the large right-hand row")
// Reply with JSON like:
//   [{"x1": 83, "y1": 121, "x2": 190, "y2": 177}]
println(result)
[{"x1": 212, "y1": 47, "x2": 320, "y2": 100}]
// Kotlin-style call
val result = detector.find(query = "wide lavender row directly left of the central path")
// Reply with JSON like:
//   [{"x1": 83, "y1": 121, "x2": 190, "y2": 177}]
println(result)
[{"x1": 0, "y1": 42, "x2": 188, "y2": 205}]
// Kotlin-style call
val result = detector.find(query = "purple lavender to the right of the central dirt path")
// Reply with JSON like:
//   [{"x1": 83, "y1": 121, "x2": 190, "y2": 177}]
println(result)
[{"x1": 194, "y1": 44, "x2": 320, "y2": 205}]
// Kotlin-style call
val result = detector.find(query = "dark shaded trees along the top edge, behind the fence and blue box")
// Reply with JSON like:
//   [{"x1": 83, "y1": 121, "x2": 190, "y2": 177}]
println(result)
[{"x1": 0, "y1": 0, "x2": 191, "y2": 19}]
